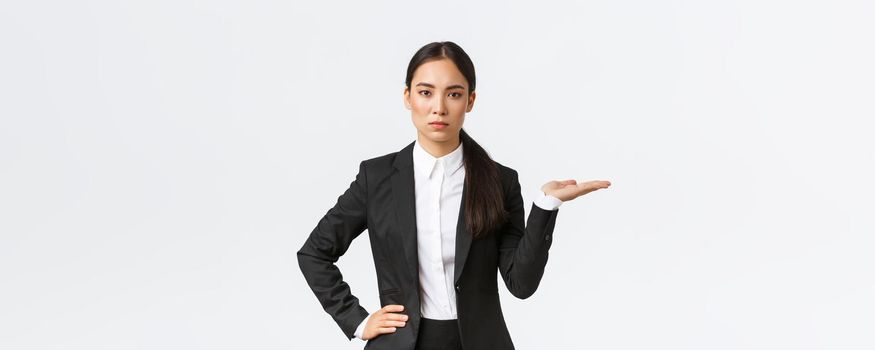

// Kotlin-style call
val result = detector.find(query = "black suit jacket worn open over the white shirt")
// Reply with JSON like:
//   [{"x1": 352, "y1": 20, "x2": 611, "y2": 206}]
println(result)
[{"x1": 297, "y1": 141, "x2": 558, "y2": 350}]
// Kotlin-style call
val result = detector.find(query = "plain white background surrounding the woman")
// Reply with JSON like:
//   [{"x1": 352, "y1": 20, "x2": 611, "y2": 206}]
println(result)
[{"x1": 0, "y1": 0, "x2": 875, "y2": 350}]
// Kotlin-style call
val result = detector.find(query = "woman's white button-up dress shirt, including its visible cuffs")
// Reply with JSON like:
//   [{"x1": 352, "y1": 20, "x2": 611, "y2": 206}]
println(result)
[{"x1": 355, "y1": 141, "x2": 562, "y2": 339}]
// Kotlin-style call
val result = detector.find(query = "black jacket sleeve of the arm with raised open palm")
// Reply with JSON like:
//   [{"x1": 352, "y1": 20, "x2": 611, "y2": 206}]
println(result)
[{"x1": 498, "y1": 169, "x2": 559, "y2": 299}]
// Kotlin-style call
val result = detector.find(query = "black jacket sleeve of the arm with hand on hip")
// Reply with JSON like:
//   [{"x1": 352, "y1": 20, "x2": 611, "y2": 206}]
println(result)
[{"x1": 297, "y1": 161, "x2": 369, "y2": 340}]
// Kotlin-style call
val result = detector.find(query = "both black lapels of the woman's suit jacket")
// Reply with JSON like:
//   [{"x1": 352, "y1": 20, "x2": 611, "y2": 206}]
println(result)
[{"x1": 391, "y1": 141, "x2": 471, "y2": 284}]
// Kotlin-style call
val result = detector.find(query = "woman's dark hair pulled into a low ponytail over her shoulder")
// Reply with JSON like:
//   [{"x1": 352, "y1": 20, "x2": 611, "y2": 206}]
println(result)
[{"x1": 404, "y1": 41, "x2": 508, "y2": 238}]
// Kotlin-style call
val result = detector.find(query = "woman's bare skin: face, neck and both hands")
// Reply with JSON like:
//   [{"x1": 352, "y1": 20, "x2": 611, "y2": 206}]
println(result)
[{"x1": 362, "y1": 58, "x2": 611, "y2": 340}]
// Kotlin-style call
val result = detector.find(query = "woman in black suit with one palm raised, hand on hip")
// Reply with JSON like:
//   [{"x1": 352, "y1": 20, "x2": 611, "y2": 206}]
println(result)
[{"x1": 297, "y1": 41, "x2": 610, "y2": 350}]
